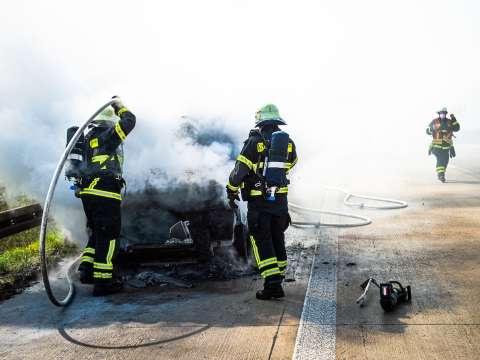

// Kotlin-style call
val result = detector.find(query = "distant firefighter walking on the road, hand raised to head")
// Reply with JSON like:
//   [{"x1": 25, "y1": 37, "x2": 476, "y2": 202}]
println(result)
[{"x1": 427, "y1": 108, "x2": 460, "y2": 183}]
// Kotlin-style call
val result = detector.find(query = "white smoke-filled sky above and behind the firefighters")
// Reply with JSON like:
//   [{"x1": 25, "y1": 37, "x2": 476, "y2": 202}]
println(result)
[{"x1": 0, "y1": 0, "x2": 480, "y2": 236}]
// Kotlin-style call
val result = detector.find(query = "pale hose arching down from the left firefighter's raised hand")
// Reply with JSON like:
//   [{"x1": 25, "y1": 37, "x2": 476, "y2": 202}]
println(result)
[{"x1": 40, "y1": 100, "x2": 113, "y2": 306}]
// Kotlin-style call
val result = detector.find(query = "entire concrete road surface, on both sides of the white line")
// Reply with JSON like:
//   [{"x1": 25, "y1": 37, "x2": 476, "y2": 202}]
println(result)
[{"x1": 0, "y1": 148, "x2": 480, "y2": 360}]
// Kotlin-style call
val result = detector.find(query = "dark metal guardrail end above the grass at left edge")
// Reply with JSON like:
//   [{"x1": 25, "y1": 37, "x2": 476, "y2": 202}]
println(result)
[{"x1": 0, "y1": 204, "x2": 43, "y2": 239}]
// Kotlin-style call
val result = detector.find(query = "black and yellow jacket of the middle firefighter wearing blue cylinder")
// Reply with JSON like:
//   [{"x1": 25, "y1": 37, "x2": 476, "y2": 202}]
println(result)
[{"x1": 227, "y1": 125, "x2": 298, "y2": 210}]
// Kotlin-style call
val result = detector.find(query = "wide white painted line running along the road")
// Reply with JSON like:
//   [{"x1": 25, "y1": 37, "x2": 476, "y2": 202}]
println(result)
[{"x1": 293, "y1": 231, "x2": 338, "y2": 360}]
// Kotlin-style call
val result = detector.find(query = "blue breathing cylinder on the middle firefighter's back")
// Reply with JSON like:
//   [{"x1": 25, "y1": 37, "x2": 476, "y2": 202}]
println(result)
[{"x1": 263, "y1": 131, "x2": 290, "y2": 201}]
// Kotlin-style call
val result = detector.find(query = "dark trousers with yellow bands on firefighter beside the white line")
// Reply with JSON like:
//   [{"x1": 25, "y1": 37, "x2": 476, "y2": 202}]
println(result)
[{"x1": 247, "y1": 207, "x2": 290, "y2": 283}]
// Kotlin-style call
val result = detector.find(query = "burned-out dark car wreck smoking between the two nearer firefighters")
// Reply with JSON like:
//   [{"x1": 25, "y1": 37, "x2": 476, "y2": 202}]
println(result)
[{"x1": 118, "y1": 181, "x2": 250, "y2": 264}]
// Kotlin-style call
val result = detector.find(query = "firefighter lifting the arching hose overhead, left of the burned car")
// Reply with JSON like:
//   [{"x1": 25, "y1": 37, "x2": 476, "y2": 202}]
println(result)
[{"x1": 78, "y1": 97, "x2": 136, "y2": 296}]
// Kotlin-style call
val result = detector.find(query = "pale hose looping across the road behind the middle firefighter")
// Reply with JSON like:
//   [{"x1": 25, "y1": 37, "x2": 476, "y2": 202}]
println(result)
[{"x1": 288, "y1": 186, "x2": 408, "y2": 228}]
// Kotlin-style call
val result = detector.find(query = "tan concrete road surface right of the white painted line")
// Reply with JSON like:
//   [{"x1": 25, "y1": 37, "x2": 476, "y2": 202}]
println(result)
[{"x1": 336, "y1": 147, "x2": 480, "y2": 359}]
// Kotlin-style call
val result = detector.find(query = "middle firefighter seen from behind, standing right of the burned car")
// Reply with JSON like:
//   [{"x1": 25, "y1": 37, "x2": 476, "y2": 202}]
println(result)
[{"x1": 226, "y1": 104, "x2": 297, "y2": 300}]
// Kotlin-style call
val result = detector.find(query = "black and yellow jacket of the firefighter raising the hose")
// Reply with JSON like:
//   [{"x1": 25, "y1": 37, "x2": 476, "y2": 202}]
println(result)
[{"x1": 80, "y1": 108, "x2": 136, "y2": 201}]
